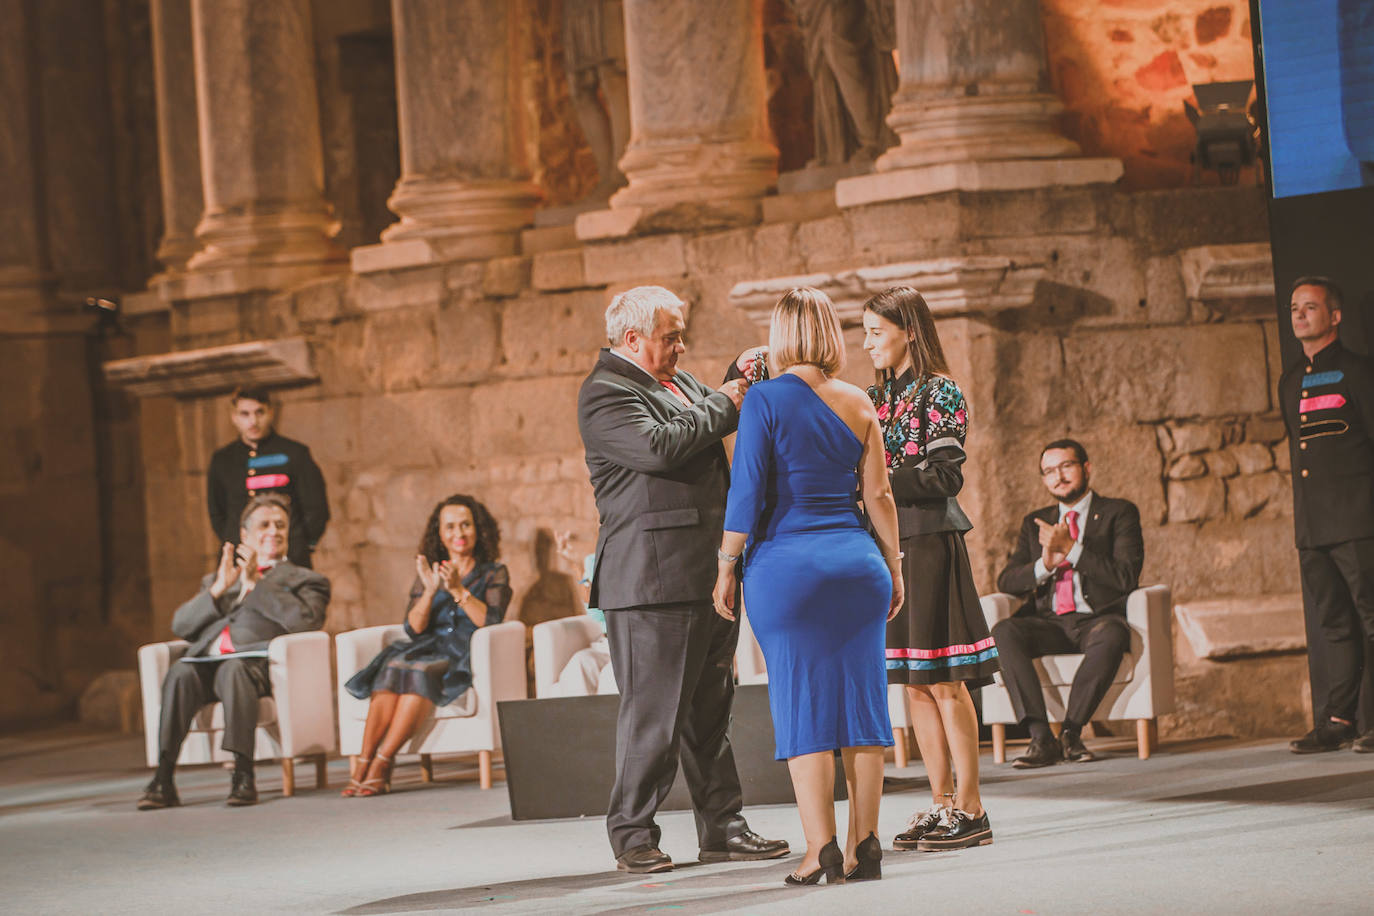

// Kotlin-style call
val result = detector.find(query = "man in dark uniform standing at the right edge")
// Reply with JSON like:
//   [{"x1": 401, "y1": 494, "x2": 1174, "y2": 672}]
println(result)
[{"x1": 1279, "y1": 276, "x2": 1374, "y2": 754}]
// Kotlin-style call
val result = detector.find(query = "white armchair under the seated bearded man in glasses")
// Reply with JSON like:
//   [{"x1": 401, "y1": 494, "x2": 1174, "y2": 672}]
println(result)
[{"x1": 982, "y1": 585, "x2": 1173, "y2": 764}]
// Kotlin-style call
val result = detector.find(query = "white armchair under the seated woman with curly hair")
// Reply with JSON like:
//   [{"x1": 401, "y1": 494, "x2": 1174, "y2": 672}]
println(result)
[{"x1": 334, "y1": 621, "x2": 528, "y2": 788}]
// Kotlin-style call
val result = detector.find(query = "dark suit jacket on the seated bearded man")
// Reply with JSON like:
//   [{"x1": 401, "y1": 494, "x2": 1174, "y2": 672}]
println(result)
[{"x1": 998, "y1": 493, "x2": 1145, "y2": 617}]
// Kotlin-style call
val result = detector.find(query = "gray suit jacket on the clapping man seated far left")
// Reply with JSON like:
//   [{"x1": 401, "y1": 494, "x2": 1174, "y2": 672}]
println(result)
[{"x1": 172, "y1": 560, "x2": 330, "y2": 658}]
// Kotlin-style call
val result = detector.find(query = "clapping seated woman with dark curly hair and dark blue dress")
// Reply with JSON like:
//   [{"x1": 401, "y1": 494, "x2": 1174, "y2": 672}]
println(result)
[{"x1": 344, "y1": 493, "x2": 511, "y2": 798}]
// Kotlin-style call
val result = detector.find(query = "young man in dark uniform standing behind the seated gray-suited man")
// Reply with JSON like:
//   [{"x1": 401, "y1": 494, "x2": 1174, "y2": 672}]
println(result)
[{"x1": 205, "y1": 387, "x2": 330, "y2": 569}]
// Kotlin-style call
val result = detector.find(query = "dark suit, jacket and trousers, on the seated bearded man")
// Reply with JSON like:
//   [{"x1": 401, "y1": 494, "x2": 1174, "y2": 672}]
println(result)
[{"x1": 992, "y1": 493, "x2": 1145, "y2": 728}]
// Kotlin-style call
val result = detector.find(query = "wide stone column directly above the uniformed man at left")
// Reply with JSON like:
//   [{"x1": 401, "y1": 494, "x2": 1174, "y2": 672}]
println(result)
[{"x1": 187, "y1": 0, "x2": 344, "y2": 281}]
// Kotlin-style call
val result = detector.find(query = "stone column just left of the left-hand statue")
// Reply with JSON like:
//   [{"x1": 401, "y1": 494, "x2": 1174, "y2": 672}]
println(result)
[{"x1": 353, "y1": 0, "x2": 540, "y2": 272}]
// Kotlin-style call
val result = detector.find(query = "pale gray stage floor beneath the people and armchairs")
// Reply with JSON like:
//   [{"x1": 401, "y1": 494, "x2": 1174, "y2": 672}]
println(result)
[{"x1": 0, "y1": 726, "x2": 1374, "y2": 916}]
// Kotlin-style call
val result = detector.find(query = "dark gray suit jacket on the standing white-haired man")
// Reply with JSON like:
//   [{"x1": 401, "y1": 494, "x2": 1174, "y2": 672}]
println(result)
[{"x1": 577, "y1": 349, "x2": 739, "y2": 610}]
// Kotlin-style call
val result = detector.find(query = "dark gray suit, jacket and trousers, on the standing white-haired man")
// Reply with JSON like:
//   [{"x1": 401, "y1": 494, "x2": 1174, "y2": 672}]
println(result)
[{"x1": 577, "y1": 349, "x2": 745, "y2": 857}]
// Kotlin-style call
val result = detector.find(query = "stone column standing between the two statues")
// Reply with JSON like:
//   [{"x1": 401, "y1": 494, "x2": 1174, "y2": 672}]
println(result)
[{"x1": 577, "y1": 0, "x2": 778, "y2": 238}]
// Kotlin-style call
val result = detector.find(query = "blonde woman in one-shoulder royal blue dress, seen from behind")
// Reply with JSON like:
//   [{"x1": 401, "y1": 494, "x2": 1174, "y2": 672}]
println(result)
[{"x1": 714, "y1": 288, "x2": 904, "y2": 884}]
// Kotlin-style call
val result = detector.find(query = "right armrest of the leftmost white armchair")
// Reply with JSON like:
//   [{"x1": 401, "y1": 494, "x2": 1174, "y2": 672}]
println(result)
[{"x1": 267, "y1": 630, "x2": 338, "y2": 757}]
